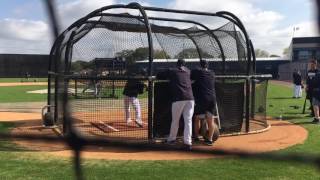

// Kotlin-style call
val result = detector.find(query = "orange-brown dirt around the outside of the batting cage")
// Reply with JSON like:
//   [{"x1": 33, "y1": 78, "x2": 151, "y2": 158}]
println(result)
[{"x1": 0, "y1": 112, "x2": 308, "y2": 160}]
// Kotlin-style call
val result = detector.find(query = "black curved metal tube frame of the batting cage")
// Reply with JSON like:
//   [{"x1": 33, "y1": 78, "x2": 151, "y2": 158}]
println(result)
[{"x1": 47, "y1": 3, "x2": 270, "y2": 139}]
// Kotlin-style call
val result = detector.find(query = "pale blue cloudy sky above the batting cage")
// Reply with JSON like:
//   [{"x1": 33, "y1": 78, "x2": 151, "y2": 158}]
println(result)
[{"x1": 0, "y1": 0, "x2": 317, "y2": 56}]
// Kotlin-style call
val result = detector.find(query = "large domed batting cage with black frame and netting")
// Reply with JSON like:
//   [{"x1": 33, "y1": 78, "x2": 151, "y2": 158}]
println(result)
[{"x1": 45, "y1": 3, "x2": 269, "y2": 141}]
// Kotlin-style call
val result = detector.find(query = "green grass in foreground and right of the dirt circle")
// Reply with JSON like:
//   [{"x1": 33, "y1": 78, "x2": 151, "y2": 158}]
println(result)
[{"x1": 0, "y1": 82, "x2": 320, "y2": 179}]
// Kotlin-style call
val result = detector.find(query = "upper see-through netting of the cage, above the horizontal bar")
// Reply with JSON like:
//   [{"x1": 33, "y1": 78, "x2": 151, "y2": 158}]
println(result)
[{"x1": 62, "y1": 15, "x2": 247, "y2": 74}]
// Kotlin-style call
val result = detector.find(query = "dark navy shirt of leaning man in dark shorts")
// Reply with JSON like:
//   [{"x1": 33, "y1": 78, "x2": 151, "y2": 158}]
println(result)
[{"x1": 191, "y1": 68, "x2": 216, "y2": 104}]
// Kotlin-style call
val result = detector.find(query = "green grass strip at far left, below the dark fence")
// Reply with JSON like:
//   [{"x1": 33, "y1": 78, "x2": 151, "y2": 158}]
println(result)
[{"x1": 0, "y1": 86, "x2": 47, "y2": 103}]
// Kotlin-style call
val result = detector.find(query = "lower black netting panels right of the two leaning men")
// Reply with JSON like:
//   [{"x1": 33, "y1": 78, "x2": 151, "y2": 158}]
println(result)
[{"x1": 216, "y1": 77, "x2": 268, "y2": 134}]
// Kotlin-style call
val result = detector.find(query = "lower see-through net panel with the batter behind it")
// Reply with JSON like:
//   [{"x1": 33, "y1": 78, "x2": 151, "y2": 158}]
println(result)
[{"x1": 68, "y1": 77, "x2": 148, "y2": 140}]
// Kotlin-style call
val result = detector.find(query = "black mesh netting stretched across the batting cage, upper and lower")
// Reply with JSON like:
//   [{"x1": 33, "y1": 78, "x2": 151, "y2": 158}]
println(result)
[{"x1": 49, "y1": 10, "x2": 265, "y2": 140}]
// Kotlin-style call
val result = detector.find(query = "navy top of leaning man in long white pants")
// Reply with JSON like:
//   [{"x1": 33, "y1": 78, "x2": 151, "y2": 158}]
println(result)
[{"x1": 157, "y1": 67, "x2": 194, "y2": 101}]
